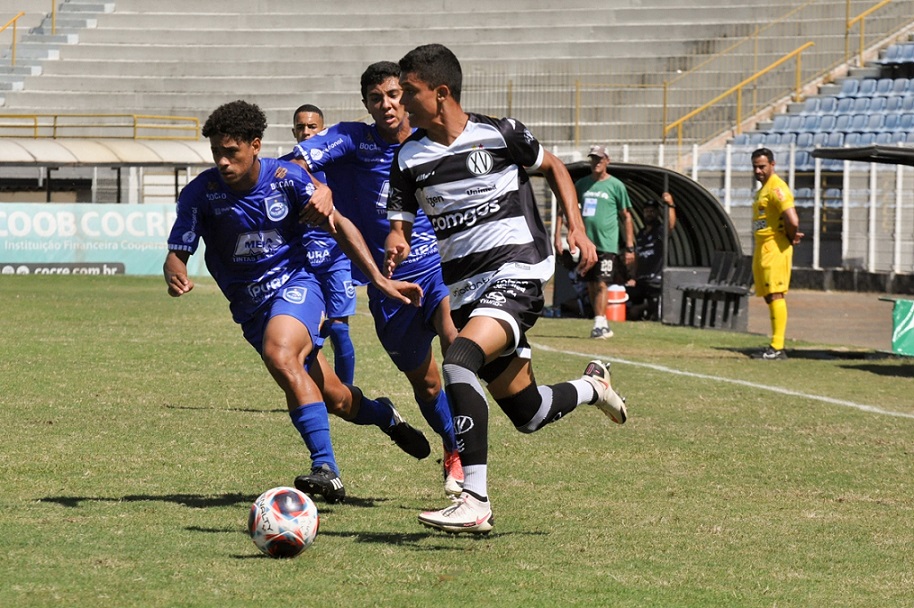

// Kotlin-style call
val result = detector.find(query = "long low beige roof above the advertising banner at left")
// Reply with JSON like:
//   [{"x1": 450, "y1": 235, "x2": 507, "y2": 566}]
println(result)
[{"x1": 0, "y1": 138, "x2": 213, "y2": 167}]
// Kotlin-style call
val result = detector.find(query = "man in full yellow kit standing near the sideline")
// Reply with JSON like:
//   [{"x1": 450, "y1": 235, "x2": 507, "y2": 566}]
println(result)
[{"x1": 752, "y1": 148, "x2": 803, "y2": 359}]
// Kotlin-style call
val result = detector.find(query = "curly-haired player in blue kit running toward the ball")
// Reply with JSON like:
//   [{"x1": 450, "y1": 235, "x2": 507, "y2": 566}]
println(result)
[{"x1": 163, "y1": 101, "x2": 429, "y2": 502}]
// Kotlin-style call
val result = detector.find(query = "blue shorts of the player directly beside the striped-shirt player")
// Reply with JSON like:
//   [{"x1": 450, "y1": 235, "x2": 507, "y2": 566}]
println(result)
[{"x1": 368, "y1": 268, "x2": 448, "y2": 372}]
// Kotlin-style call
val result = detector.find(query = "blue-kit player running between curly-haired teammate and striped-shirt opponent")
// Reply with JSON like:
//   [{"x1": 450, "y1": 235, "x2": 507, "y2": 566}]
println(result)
[{"x1": 295, "y1": 61, "x2": 463, "y2": 496}]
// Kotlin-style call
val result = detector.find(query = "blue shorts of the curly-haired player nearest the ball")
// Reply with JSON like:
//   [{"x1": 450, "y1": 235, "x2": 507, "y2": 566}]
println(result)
[{"x1": 241, "y1": 271, "x2": 324, "y2": 356}]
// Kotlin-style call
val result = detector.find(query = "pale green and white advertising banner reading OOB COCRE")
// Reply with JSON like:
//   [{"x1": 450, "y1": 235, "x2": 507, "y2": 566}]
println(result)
[{"x1": 0, "y1": 203, "x2": 207, "y2": 276}]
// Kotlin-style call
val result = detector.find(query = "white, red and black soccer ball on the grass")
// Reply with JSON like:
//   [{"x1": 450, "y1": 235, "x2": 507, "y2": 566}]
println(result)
[{"x1": 248, "y1": 487, "x2": 320, "y2": 557}]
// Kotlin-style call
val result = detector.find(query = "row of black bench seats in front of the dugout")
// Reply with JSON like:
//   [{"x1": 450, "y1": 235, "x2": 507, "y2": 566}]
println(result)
[{"x1": 676, "y1": 251, "x2": 753, "y2": 329}]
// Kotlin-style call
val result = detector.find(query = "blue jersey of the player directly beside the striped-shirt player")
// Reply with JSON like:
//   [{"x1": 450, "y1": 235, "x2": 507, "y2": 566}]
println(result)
[{"x1": 294, "y1": 122, "x2": 441, "y2": 283}]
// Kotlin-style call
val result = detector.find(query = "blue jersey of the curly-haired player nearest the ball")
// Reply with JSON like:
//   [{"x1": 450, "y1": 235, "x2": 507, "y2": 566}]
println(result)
[{"x1": 168, "y1": 158, "x2": 314, "y2": 323}]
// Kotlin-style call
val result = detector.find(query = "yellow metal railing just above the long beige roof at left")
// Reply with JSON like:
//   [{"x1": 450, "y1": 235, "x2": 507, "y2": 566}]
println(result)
[{"x1": 0, "y1": 114, "x2": 200, "y2": 140}]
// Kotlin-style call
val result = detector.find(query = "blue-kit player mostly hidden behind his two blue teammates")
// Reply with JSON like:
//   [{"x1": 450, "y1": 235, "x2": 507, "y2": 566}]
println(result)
[{"x1": 280, "y1": 104, "x2": 356, "y2": 384}]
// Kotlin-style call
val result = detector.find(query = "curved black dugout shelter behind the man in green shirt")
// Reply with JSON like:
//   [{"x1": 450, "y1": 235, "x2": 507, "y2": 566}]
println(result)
[{"x1": 567, "y1": 161, "x2": 743, "y2": 266}]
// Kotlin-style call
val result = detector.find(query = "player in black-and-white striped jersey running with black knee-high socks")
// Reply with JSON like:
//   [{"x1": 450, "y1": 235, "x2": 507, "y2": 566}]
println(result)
[{"x1": 386, "y1": 44, "x2": 626, "y2": 533}]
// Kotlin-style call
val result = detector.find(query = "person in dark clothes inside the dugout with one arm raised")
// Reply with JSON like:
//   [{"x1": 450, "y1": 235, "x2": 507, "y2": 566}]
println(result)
[{"x1": 625, "y1": 192, "x2": 676, "y2": 321}]
